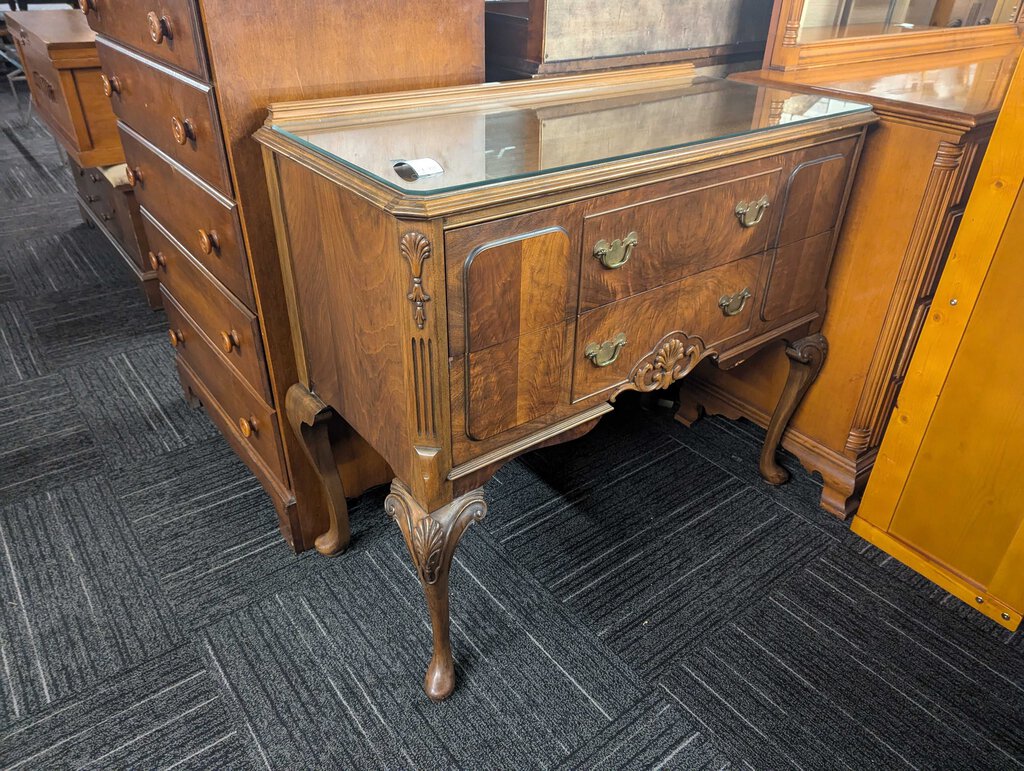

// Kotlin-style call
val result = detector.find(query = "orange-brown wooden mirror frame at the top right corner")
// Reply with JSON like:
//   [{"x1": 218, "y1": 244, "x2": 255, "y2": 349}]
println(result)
[{"x1": 764, "y1": 0, "x2": 1024, "y2": 72}]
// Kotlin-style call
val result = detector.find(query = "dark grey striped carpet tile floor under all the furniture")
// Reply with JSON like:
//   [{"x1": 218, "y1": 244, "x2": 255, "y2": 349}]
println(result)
[{"x1": 0, "y1": 76, "x2": 1024, "y2": 769}]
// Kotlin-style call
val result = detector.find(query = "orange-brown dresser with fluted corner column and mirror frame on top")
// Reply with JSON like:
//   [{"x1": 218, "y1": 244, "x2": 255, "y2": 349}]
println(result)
[{"x1": 680, "y1": 1, "x2": 1021, "y2": 518}]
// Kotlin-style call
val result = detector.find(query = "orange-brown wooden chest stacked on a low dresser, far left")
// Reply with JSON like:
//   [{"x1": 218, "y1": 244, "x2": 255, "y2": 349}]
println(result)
[{"x1": 4, "y1": 9, "x2": 124, "y2": 167}]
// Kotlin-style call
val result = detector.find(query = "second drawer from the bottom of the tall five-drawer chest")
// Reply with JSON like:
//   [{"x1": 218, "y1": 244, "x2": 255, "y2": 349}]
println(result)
[{"x1": 143, "y1": 214, "x2": 272, "y2": 401}]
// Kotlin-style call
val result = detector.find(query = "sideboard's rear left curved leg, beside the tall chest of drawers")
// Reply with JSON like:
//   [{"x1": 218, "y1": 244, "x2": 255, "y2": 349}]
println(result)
[{"x1": 285, "y1": 383, "x2": 351, "y2": 557}]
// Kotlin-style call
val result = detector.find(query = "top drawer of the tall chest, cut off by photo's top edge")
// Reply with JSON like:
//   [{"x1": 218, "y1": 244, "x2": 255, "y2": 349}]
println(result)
[{"x1": 86, "y1": 0, "x2": 209, "y2": 80}]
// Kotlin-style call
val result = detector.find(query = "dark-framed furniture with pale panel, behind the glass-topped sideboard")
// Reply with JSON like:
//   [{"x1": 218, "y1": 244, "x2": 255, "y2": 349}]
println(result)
[{"x1": 484, "y1": 0, "x2": 771, "y2": 80}]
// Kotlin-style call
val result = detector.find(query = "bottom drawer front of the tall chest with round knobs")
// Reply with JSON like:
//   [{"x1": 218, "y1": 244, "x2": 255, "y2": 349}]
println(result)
[{"x1": 161, "y1": 287, "x2": 288, "y2": 479}]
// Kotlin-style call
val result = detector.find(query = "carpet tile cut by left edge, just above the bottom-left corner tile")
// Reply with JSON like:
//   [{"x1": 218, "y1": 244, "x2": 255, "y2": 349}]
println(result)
[{"x1": 0, "y1": 478, "x2": 181, "y2": 722}]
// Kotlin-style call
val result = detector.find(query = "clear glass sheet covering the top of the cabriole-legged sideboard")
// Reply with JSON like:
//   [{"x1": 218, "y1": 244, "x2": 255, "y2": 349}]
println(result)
[{"x1": 272, "y1": 78, "x2": 870, "y2": 196}]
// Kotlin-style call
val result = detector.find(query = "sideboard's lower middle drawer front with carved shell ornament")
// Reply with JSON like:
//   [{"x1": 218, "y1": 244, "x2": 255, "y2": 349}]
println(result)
[{"x1": 572, "y1": 255, "x2": 763, "y2": 401}]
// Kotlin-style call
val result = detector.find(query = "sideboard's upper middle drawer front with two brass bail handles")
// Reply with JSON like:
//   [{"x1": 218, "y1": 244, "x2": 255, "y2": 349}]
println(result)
[{"x1": 580, "y1": 165, "x2": 782, "y2": 311}]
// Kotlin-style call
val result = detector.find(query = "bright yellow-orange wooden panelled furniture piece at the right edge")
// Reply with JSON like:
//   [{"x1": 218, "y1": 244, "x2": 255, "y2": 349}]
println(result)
[{"x1": 852, "y1": 52, "x2": 1024, "y2": 630}]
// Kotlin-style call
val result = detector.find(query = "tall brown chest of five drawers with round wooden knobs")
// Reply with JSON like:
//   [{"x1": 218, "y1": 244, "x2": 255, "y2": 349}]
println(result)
[{"x1": 81, "y1": 0, "x2": 483, "y2": 553}]
